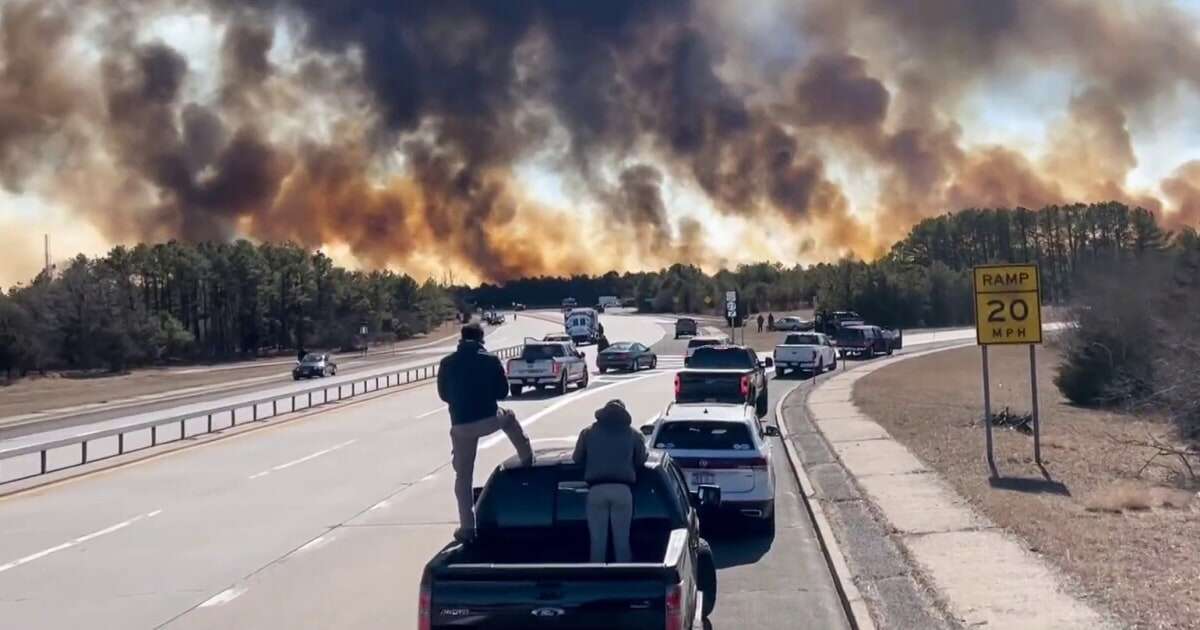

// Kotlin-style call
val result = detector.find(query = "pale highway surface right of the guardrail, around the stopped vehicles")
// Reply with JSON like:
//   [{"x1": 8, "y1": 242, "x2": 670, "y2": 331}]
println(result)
[{"x1": 0, "y1": 316, "x2": 846, "y2": 629}]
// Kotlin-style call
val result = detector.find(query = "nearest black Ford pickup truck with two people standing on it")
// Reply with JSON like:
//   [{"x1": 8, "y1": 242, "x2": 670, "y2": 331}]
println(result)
[{"x1": 418, "y1": 448, "x2": 721, "y2": 630}]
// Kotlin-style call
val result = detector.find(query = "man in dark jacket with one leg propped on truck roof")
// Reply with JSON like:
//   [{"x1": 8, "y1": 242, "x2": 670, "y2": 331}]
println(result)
[{"x1": 438, "y1": 324, "x2": 533, "y2": 540}]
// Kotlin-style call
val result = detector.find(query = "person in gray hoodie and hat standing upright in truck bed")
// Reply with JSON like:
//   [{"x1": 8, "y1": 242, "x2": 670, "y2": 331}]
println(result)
[{"x1": 575, "y1": 400, "x2": 648, "y2": 563}]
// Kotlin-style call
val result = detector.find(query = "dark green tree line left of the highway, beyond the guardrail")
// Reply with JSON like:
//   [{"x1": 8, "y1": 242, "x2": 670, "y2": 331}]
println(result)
[{"x1": 0, "y1": 240, "x2": 454, "y2": 374}]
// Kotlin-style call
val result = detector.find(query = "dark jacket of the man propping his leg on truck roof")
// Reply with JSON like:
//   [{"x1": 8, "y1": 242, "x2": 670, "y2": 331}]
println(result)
[{"x1": 438, "y1": 341, "x2": 509, "y2": 425}]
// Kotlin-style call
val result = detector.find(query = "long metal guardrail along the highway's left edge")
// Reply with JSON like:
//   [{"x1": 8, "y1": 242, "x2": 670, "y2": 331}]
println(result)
[{"x1": 0, "y1": 344, "x2": 524, "y2": 485}]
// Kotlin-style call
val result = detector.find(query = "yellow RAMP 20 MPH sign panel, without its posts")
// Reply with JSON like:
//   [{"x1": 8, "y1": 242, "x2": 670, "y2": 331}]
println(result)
[{"x1": 974, "y1": 265, "x2": 1042, "y2": 346}]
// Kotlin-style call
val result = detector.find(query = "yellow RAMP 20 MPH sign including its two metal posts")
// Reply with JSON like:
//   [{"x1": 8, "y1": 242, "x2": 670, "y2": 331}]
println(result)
[{"x1": 972, "y1": 264, "x2": 1042, "y2": 474}]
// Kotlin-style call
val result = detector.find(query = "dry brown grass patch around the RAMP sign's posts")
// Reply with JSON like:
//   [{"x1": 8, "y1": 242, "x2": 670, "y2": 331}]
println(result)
[{"x1": 854, "y1": 347, "x2": 1200, "y2": 628}]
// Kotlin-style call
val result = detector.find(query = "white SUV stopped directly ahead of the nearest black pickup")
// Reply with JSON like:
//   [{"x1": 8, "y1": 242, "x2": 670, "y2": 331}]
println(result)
[{"x1": 642, "y1": 403, "x2": 779, "y2": 532}]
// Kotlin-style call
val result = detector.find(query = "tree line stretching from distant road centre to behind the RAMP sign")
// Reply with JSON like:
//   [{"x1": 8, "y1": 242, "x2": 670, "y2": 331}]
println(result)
[{"x1": 469, "y1": 202, "x2": 1171, "y2": 326}]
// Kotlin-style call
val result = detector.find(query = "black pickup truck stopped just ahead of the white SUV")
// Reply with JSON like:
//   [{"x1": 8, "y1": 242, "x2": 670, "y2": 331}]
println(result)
[{"x1": 676, "y1": 346, "x2": 775, "y2": 418}]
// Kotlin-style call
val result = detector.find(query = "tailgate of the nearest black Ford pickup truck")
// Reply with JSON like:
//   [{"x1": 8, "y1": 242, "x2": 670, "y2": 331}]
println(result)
[{"x1": 431, "y1": 565, "x2": 666, "y2": 630}]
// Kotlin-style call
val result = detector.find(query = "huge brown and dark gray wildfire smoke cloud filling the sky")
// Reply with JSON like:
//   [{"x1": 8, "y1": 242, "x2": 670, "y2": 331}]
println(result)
[{"x1": 0, "y1": 0, "x2": 1200, "y2": 281}]
